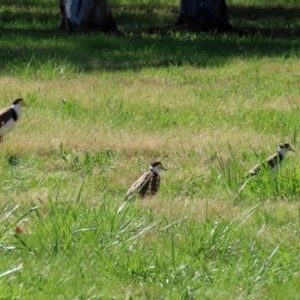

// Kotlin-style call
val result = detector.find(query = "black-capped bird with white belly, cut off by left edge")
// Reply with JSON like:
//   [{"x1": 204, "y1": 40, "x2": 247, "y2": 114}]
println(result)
[{"x1": 0, "y1": 98, "x2": 26, "y2": 143}]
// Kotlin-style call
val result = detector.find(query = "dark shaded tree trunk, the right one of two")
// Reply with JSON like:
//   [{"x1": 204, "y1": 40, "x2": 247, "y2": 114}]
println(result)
[{"x1": 177, "y1": 0, "x2": 232, "y2": 31}]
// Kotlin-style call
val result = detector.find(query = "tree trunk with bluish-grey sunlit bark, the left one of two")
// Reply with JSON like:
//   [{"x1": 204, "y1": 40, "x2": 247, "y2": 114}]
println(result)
[{"x1": 59, "y1": 0, "x2": 118, "y2": 32}]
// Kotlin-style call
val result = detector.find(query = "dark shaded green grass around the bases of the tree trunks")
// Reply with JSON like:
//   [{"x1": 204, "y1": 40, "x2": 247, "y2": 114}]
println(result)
[{"x1": 0, "y1": 2, "x2": 300, "y2": 73}]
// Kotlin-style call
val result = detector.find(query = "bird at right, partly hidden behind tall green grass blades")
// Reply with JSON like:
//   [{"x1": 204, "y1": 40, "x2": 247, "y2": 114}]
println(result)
[{"x1": 249, "y1": 143, "x2": 295, "y2": 176}]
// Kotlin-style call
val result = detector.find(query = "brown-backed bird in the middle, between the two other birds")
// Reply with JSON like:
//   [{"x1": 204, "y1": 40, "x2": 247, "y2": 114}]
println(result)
[{"x1": 125, "y1": 161, "x2": 166, "y2": 198}]
